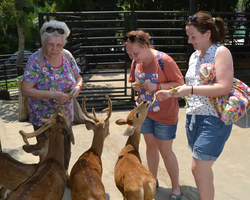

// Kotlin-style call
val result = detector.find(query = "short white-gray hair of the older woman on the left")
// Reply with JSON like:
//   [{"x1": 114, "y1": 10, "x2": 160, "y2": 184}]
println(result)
[{"x1": 40, "y1": 20, "x2": 70, "y2": 46}]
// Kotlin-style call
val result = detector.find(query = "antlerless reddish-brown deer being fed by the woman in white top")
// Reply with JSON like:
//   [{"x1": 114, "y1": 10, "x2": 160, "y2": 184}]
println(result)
[{"x1": 114, "y1": 101, "x2": 156, "y2": 200}]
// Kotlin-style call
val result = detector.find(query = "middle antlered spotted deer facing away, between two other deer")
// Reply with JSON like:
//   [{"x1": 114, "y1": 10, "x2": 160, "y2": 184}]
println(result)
[{"x1": 69, "y1": 96, "x2": 112, "y2": 200}]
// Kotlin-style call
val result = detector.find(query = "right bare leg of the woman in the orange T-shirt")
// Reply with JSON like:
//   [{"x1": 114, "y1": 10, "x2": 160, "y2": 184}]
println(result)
[{"x1": 157, "y1": 139, "x2": 181, "y2": 195}]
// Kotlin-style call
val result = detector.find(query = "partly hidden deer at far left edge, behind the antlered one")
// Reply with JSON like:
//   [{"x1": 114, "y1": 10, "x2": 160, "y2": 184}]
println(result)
[{"x1": 0, "y1": 137, "x2": 49, "y2": 199}]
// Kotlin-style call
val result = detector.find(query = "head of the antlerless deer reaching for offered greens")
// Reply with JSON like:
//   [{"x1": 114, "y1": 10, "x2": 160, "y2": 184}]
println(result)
[{"x1": 115, "y1": 101, "x2": 150, "y2": 136}]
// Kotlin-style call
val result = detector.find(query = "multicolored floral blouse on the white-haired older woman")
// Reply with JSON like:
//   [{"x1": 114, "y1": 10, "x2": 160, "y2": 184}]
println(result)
[{"x1": 23, "y1": 50, "x2": 79, "y2": 126}]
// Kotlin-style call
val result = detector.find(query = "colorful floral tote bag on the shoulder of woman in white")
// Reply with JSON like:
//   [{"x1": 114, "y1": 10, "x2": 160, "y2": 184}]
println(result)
[{"x1": 199, "y1": 63, "x2": 250, "y2": 125}]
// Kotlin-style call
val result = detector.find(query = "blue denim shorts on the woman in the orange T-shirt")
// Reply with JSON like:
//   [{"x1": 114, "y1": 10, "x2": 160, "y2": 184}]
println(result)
[{"x1": 141, "y1": 117, "x2": 177, "y2": 140}]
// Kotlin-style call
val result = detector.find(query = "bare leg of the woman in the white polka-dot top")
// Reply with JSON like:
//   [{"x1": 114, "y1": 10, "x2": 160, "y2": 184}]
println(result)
[{"x1": 192, "y1": 158, "x2": 214, "y2": 200}]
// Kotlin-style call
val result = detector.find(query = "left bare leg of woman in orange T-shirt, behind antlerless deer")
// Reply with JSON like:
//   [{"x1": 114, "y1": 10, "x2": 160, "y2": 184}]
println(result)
[{"x1": 143, "y1": 134, "x2": 159, "y2": 179}]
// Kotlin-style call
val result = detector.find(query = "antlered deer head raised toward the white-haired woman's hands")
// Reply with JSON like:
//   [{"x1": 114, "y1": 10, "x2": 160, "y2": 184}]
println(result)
[{"x1": 19, "y1": 106, "x2": 75, "y2": 144}]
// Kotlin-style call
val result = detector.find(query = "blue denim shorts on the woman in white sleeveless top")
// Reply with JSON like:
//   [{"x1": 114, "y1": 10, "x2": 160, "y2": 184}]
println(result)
[{"x1": 186, "y1": 115, "x2": 233, "y2": 161}]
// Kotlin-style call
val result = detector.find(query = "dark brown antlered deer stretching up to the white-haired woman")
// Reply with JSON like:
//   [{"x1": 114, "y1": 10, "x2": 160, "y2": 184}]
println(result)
[{"x1": 9, "y1": 106, "x2": 75, "y2": 200}]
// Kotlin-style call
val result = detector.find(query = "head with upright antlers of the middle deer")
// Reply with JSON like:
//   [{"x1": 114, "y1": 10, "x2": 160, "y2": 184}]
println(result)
[{"x1": 82, "y1": 95, "x2": 112, "y2": 137}]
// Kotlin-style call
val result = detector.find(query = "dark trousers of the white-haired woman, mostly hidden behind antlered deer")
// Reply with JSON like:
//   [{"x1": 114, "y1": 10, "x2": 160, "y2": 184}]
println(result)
[{"x1": 33, "y1": 125, "x2": 71, "y2": 170}]
